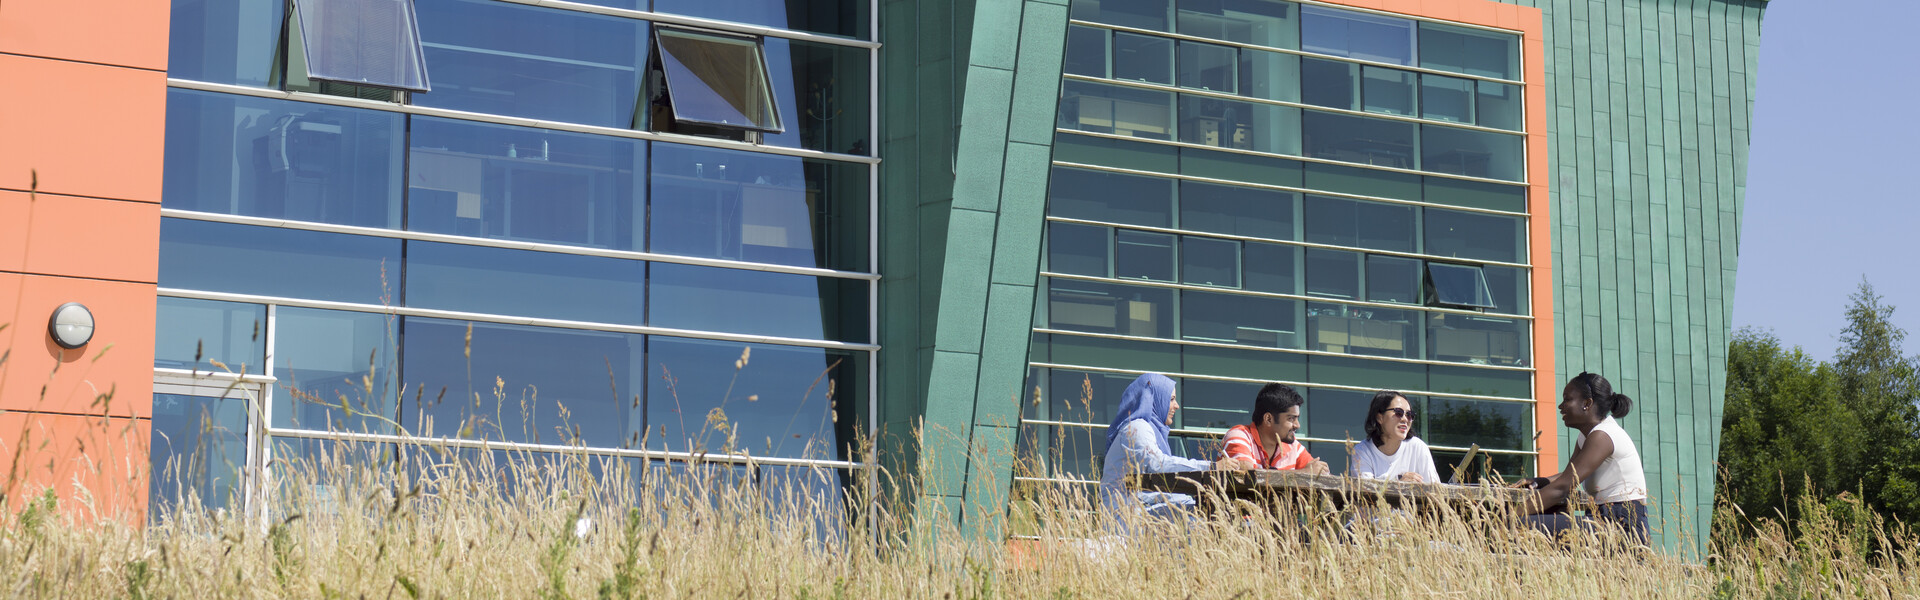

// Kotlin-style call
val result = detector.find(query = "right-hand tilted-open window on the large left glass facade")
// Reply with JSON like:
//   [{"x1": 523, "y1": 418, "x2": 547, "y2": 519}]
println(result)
[{"x1": 655, "y1": 27, "x2": 783, "y2": 133}]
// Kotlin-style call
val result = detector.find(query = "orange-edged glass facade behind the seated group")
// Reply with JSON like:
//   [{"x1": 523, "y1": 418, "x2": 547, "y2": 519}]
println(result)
[{"x1": 1020, "y1": 0, "x2": 1549, "y2": 488}]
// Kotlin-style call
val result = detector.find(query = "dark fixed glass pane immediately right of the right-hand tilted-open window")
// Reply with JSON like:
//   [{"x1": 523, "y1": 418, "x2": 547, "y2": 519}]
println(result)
[{"x1": 762, "y1": 38, "x2": 874, "y2": 156}]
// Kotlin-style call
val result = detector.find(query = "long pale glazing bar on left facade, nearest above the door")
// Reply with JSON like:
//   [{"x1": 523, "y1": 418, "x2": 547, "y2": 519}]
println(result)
[{"x1": 159, "y1": 288, "x2": 879, "y2": 352}]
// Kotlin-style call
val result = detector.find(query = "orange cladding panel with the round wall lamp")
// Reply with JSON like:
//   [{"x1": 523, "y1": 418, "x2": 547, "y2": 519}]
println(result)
[{"x1": 0, "y1": 273, "x2": 154, "y2": 417}]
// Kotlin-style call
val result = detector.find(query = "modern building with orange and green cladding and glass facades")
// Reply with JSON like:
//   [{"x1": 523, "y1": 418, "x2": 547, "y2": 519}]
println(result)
[{"x1": 0, "y1": 0, "x2": 1764, "y2": 546}]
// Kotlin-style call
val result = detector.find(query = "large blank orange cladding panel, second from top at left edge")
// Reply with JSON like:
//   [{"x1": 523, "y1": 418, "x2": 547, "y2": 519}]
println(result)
[{"x1": 0, "y1": 54, "x2": 167, "y2": 202}]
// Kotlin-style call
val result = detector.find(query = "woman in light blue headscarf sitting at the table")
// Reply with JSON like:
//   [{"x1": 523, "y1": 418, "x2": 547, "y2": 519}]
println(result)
[{"x1": 1100, "y1": 373, "x2": 1235, "y2": 515}]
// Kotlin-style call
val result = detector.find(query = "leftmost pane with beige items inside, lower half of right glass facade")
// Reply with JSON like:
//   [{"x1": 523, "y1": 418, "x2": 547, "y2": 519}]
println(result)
[{"x1": 1046, "y1": 279, "x2": 1173, "y2": 340}]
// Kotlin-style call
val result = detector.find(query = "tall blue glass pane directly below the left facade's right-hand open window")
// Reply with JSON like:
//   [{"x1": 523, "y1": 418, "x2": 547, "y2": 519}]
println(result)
[{"x1": 651, "y1": 144, "x2": 868, "y2": 271}]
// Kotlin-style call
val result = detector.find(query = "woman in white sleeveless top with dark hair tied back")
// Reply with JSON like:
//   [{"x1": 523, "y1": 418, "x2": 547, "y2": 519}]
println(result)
[{"x1": 1513, "y1": 373, "x2": 1647, "y2": 544}]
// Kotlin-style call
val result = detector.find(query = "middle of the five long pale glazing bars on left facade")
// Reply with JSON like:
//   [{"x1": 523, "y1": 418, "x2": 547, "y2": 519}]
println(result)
[{"x1": 159, "y1": 208, "x2": 879, "y2": 281}]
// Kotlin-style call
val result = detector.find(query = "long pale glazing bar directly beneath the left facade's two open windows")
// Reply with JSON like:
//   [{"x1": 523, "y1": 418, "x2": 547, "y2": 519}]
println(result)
[{"x1": 167, "y1": 79, "x2": 879, "y2": 165}]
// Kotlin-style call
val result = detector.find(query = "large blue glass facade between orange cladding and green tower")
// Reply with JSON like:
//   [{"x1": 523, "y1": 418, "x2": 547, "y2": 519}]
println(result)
[{"x1": 152, "y1": 0, "x2": 879, "y2": 519}]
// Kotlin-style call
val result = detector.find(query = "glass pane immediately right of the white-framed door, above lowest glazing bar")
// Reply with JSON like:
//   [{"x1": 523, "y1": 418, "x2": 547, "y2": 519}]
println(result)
[{"x1": 273, "y1": 306, "x2": 399, "y2": 433}]
